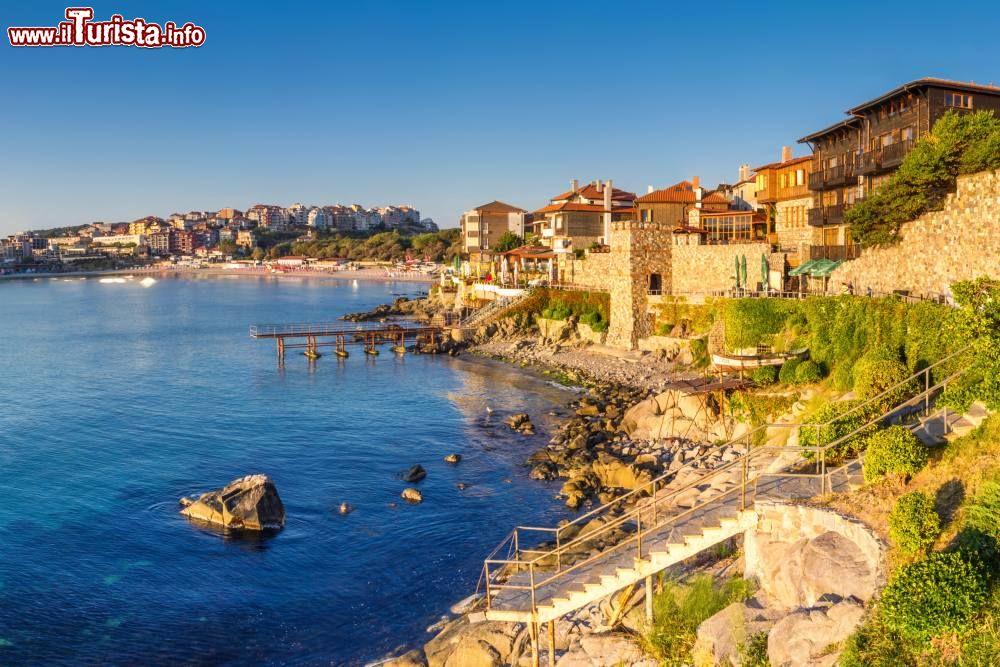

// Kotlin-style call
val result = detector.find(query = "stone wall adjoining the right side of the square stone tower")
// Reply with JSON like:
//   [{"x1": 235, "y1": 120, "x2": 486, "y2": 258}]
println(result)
[{"x1": 670, "y1": 243, "x2": 771, "y2": 294}]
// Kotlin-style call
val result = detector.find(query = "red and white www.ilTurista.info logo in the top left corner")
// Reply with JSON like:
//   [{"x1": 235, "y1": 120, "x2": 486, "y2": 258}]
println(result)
[{"x1": 7, "y1": 7, "x2": 205, "y2": 49}]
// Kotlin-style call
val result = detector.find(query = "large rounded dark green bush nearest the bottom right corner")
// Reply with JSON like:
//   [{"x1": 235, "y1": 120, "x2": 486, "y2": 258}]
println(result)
[{"x1": 881, "y1": 551, "x2": 987, "y2": 639}]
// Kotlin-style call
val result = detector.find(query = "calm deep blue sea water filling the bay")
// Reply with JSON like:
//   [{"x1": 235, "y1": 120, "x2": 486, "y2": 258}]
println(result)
[{"x1": 0, "y1": 277, "x2": 570, "y2": 665}]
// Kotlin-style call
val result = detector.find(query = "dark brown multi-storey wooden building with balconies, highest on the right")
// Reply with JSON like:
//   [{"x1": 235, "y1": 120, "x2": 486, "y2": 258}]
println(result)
[{"x1": 799, "y1": 78, "x2": 1000, "y2": 260}]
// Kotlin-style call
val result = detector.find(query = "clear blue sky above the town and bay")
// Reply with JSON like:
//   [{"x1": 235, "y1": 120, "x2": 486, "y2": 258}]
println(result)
[{"x1": 0, "y1": 0, "x2": 1000, "y2": 233}]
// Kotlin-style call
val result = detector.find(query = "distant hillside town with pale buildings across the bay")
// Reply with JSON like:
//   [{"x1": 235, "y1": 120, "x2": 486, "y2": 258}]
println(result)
[{"x1": 0, "y1": 203, "x2": 438, "y2": 273}]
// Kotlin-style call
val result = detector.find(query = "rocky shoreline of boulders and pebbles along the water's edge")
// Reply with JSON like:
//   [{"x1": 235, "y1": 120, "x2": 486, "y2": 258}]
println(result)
[{"x1": 345, "y1": 295, "x2": 756, "y2": 667}]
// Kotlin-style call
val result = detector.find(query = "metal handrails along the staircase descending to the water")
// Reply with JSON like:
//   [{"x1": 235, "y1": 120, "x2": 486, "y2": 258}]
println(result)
[{"x1": 482, "y1": 346, "x2": 971, "y2": 612}]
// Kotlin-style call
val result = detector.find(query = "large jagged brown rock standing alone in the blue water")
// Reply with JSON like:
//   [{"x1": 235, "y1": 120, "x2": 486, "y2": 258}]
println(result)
[{"x1": 180, "y1": 475, "x2": 285, "y2": 530}]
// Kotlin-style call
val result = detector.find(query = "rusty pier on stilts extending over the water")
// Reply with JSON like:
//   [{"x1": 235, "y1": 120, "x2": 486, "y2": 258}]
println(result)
[{"x1": 250, "y1": 321, "x2": 444, "y2": 363}]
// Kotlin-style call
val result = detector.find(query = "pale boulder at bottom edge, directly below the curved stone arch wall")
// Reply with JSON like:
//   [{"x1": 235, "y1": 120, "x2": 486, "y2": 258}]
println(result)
[{"x1": 767, "y1": 600, "x2": 865, "y2": 667}]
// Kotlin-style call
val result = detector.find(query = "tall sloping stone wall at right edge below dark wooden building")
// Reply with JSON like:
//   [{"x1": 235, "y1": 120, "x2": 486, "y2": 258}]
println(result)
[{"x1": 830, "y1": 171, "x2": 1000, "y2": 295}]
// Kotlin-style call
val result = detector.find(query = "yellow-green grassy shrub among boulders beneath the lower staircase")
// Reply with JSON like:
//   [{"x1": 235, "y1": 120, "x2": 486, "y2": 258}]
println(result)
[{"x1": 643, "y1": 574, "x2": 753, "y2": 666}]
